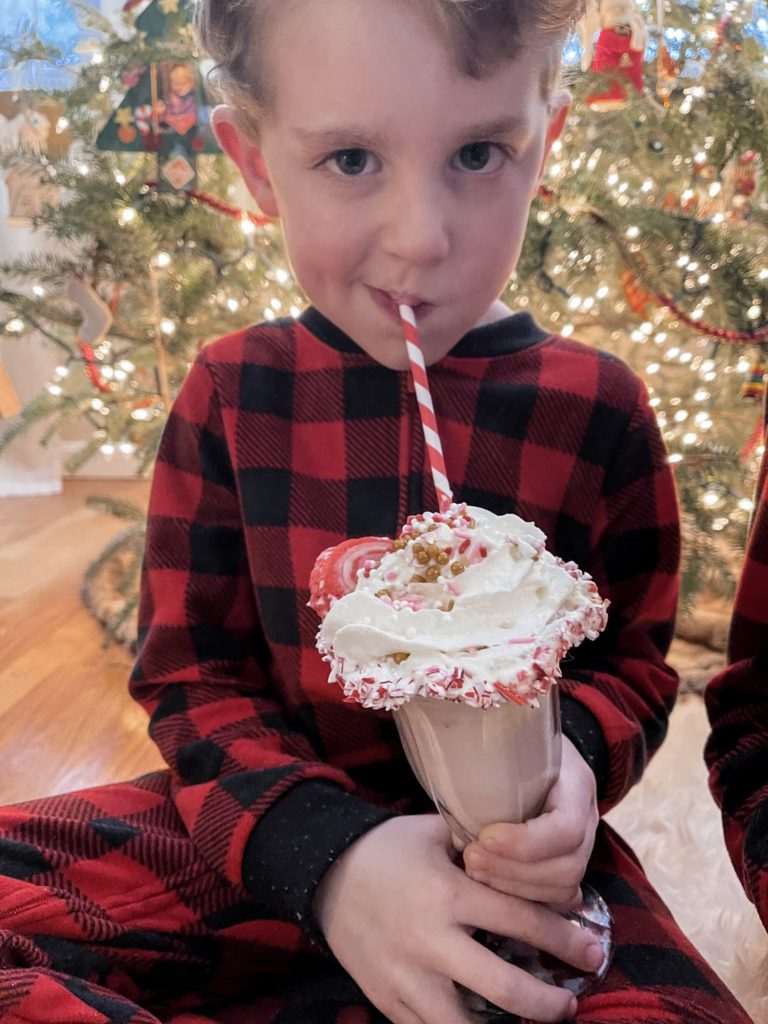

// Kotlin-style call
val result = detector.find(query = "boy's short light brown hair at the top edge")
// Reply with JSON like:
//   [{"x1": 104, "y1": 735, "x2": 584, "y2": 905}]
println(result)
[{"x1": 196, "y1": 0, "x2": 585, "y2": 130}]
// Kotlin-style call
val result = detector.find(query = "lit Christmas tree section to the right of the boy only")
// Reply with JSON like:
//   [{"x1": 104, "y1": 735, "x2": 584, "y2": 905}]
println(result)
[{"x1": 509, "y1": 0, "x2": 768, "y2": 601}]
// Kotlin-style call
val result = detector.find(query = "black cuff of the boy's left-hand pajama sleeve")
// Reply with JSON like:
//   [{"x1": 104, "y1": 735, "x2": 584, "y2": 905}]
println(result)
[{"x1": 243, "y1": 779, "x2": 395, "y2": 945}]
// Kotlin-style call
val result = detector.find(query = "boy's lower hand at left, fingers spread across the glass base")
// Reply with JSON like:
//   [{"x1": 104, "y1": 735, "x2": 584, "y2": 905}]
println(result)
[{"x1": 314, "y1": 815, "x2": 602, "y2": 1024}]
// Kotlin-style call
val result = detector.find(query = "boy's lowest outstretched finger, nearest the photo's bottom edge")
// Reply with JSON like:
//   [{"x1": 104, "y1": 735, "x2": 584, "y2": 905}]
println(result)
[{"x1": 438, "y1": 935, "x2": 575, "y2": 1022}]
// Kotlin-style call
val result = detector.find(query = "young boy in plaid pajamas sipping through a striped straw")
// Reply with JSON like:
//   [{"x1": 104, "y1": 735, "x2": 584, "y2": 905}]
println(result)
[{"x1": 0, "y1": 0, "x2": 748, "y2": 1024}]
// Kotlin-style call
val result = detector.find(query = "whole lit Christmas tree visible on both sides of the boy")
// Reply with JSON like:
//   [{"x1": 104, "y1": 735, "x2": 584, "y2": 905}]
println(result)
[{"x1": 0, "y1": 0, "x2": 768, "y2": 634}]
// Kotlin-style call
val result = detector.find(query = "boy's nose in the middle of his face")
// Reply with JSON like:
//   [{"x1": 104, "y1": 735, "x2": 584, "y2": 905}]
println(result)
[{"x1": 382, "y1": 185, "x2": 451, "y2": 266}]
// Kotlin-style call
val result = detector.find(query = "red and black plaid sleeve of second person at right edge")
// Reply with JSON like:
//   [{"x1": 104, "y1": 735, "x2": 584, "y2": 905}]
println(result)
[{"x1": 705, "y1": 395, "x2": 768, "y2": 927}]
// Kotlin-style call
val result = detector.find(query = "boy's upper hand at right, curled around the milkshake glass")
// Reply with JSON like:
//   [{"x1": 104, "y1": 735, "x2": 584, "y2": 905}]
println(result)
[{"x1": 464, "y1": 736, "x2": 599, "y2": 909}]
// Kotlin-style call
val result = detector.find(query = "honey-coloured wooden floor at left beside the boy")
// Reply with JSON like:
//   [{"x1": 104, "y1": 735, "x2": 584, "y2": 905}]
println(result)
[{"x1": 0, "y1": 480, "x2": 161, "y2": 804}]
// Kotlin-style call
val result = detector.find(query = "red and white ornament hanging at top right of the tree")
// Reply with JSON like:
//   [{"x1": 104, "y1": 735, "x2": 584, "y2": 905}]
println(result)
[{"x1": 580, "y1": 0, "x2": 648, "y2": 111}]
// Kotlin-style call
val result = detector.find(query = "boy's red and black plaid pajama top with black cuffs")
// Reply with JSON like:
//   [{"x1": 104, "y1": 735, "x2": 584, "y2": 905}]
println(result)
[{"x1": 131, "y1": 309, "x2": 679, "y2": 945}]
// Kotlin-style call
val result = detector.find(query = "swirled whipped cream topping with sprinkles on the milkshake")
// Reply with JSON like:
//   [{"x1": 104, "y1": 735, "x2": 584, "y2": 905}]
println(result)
[{"x1": 317, "y1": 505, "x2": 607, "y2": 710}]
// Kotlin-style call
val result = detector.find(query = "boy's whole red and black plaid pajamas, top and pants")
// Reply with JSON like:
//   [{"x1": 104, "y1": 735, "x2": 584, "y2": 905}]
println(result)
[{"x1": 0, "y1": 309, "x2": 749, "y2": 1024}]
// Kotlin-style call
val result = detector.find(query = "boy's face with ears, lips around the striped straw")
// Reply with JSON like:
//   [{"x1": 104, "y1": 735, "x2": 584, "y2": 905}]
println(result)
[{"x1": 214, "y1": 0, "x2": 562, "y2": 369}]
